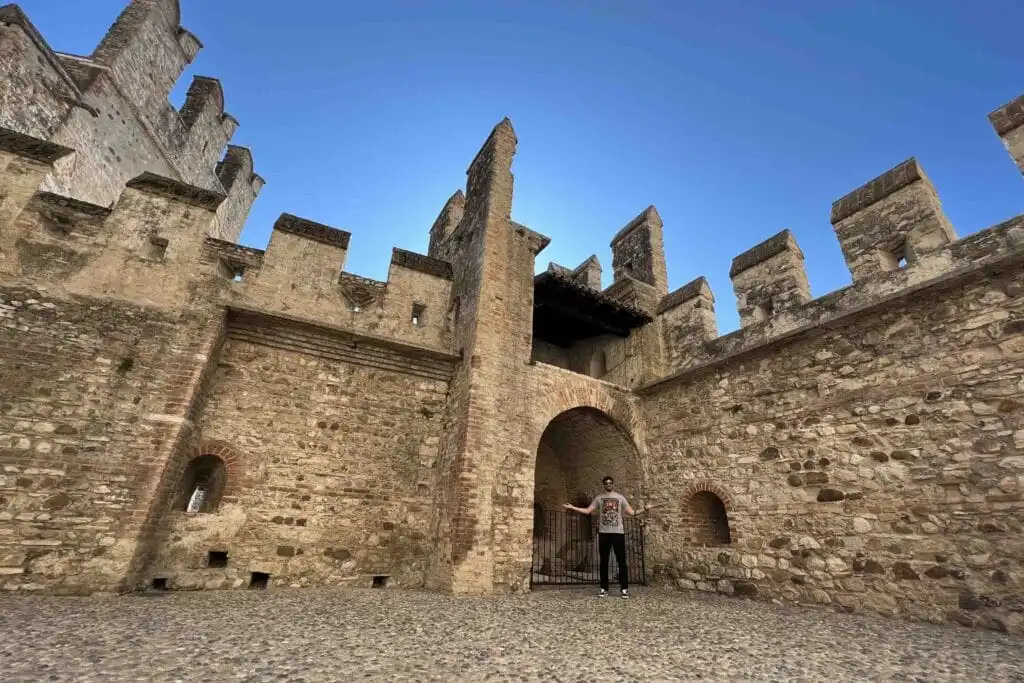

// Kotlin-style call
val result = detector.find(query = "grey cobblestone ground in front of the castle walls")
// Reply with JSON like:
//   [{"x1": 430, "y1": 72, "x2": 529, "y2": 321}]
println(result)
[{"x1": 0, "y1": 589, "x2": 1024, "y2": 683}]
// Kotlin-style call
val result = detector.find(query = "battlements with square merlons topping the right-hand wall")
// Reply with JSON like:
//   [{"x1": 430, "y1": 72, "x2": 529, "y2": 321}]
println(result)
[{"x1": 655, "y1": 89, "x2": 1024, "y2": 383}]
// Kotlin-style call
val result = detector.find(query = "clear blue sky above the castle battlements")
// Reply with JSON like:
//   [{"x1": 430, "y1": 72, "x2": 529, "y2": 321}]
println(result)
[{"x1": 19, "y1": 0, "x2": 1024, "y2": 333}]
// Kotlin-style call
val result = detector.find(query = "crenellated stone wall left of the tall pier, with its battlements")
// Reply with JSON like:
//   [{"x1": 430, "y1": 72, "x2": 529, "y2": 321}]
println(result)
[{"x1": 0, "y1": 125, "x2": 459, "y2": 593}]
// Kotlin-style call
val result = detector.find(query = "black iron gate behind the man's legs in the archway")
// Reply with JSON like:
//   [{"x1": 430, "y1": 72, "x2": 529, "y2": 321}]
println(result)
[{"x1": 529, "y1": 507, "x2": 646, "y2": 586}]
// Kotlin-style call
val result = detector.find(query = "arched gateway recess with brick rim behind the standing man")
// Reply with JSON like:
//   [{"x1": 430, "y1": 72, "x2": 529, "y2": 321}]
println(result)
[{"x1": 530, "y1": 407, "x2": 644, "y2": 586}]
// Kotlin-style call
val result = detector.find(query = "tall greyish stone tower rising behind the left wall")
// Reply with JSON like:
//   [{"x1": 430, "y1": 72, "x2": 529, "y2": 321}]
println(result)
[{"x1": 0, "y1": 0, "x2": 262, "y2": 240}]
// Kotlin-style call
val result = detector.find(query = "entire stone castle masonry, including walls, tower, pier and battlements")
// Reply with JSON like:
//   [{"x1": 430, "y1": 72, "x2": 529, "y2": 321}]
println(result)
[{"x1": 0, "y1": 0, "x2": 1024, "y2": 634}]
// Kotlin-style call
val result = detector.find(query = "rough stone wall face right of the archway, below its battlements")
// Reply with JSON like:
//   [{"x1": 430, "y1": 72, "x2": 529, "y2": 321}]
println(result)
[{"x1": 644, "y1": 244, "x2": 1024, "y2": 630}]
